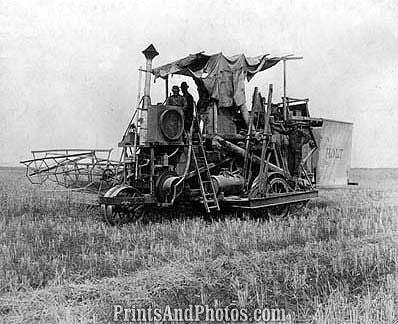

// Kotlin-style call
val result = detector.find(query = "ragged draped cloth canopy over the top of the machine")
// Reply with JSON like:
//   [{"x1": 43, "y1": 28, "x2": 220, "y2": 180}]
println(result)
[{"x1": 152, "y1": 53, "x2": 283, "y2": 107}]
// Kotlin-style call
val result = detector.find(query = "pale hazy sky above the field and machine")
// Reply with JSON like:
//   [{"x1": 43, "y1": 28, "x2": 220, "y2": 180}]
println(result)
[{"x1": 0, "y1": 0, "x2": 398, "y2": 167}]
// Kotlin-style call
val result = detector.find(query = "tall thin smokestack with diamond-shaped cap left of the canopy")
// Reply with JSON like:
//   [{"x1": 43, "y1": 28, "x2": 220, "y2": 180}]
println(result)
[{"x1": 140, "y1": 44, "x2": 159, "y2": 143}]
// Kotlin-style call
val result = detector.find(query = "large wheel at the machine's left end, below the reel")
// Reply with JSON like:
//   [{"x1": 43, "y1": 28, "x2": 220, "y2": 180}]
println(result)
[{"x1": 101, "y1": 187, "x2": 145, "y2": 225}]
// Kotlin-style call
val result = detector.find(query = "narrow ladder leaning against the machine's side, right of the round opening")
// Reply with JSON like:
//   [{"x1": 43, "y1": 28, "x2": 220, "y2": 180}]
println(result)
[{"x1": 192, "y1": 118, "x2": 220, "y2": 213}]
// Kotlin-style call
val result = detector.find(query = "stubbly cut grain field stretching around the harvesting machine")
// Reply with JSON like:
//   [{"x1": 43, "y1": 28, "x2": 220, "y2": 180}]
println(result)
[{"x1": 0, "y1": 168, "x2": 398, "y2": 324}]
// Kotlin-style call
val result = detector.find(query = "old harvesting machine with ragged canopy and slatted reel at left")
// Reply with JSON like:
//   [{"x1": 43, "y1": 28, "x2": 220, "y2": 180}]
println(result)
[{"x1": 21, "y1": 45, "x2": 352, "y2": 224}]
